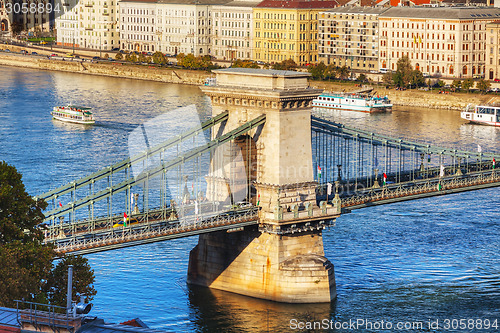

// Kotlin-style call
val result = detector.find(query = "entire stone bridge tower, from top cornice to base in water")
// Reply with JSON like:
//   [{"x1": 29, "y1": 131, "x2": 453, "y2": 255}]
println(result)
[{"x1": 188, "y1": 68, "x2": 340, "y2": 303}]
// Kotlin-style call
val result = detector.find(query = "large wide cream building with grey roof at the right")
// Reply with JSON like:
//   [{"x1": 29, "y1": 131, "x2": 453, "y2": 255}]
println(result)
[{"x1": 379, "y1": 7, "x2": 500, "y2": 78}]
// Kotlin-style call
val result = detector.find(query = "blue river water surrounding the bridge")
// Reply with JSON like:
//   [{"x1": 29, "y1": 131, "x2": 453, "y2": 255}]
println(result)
[{"x1": 0, "y1": 67, "x2": 500, "y2": 332}]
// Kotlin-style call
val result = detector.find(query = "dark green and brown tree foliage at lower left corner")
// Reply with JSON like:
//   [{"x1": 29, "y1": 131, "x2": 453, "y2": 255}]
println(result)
[{"x1": 0, "y1": 161, "x2": 95, "y2": 307}]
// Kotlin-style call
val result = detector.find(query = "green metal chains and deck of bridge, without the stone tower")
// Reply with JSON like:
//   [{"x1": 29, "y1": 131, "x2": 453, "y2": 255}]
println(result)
[{"x1": 37, "y1": 113, "x2": 500, "y2": 255}]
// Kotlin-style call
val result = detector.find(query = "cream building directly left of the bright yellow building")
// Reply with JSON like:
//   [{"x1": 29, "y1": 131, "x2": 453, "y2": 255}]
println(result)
[{"x1": 211, "y1": 0, "x2": 261, "y2": 60}]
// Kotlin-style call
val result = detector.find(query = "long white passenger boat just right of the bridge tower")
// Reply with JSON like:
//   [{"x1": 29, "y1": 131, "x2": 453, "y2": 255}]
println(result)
[{"x1": 312, "y1": 93, "x2": 392, "y2": 113}]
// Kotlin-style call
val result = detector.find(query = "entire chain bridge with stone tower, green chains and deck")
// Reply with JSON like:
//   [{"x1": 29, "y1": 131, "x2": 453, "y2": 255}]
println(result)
[{"x1": 36, "y1": 69, "x2": 500, "y2": 302}]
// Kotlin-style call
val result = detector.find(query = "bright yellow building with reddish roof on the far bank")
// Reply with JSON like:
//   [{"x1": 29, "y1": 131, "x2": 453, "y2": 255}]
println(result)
[{"x1": 253, "y1": 0, "x2": 343, "y2": 66}]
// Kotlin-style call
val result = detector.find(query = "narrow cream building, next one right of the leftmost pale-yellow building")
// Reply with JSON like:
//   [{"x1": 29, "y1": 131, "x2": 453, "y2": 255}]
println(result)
[{"x1": 118, "y1": 0, "x2": 159, "y2": 52}]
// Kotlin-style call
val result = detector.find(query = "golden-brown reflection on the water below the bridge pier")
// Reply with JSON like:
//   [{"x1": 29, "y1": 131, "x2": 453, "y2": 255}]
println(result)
[{"x1": 188, "y1": 285, "x2": 336, "y2": 332}]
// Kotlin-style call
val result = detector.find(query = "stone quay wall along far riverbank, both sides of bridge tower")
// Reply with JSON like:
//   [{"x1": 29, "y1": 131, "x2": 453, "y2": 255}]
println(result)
[{"x1": 0, "y1": 45, "x2": 500, "y2": 111}]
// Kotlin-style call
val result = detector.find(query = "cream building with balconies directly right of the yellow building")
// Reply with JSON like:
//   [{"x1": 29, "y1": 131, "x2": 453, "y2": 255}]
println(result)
[{"x1": 318, "y1": 6, "x2": 387, "y2": 70}]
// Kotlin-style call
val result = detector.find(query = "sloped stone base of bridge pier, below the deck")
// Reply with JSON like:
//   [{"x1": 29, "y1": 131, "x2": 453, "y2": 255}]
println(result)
[{"x1": 188, "y1": 228, "x2": 337, "y2": 303}]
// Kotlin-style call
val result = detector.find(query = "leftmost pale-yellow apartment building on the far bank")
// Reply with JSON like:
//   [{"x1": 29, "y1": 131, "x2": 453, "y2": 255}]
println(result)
[{"x1": 55, "y1": 0, "x2": 120, "y2": 51}]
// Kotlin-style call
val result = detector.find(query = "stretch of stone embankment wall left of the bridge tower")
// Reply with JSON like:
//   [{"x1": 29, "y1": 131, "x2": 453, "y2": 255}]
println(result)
[{"x1": 0, "y1": 53, "x2": 210, "y2": 85}]
